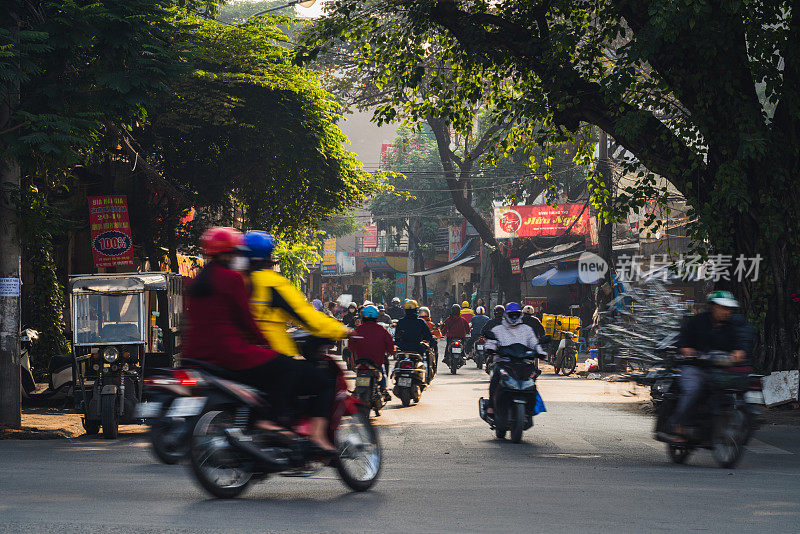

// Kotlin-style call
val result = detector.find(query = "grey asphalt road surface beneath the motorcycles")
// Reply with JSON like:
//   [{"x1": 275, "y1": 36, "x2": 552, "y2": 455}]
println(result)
[{"x1": 0, "y1": 342, "x2": 800, "y2": 533}]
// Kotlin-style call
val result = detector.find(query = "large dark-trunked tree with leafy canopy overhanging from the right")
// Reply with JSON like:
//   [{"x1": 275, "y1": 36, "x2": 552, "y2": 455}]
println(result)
[{"x1": 304, "y1": 0, "x2": 800, "y2": 369}]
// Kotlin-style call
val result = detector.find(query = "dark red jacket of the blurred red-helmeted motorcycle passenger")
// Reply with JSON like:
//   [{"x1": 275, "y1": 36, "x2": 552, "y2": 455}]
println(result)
[{"x1": 182, "y1": 263, "x2": 277, "y2": 371}]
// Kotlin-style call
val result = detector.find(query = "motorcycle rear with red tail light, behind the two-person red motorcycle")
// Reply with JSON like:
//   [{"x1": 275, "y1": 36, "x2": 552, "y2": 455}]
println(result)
[{"x1": 136, "y1": 368, "x2": 205, "y2": 465}]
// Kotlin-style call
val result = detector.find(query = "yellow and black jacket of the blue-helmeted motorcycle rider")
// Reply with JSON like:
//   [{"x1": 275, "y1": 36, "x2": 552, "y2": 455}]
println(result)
[{"x1": 250, "y1": 269, "x2": 347, "y2": 356}]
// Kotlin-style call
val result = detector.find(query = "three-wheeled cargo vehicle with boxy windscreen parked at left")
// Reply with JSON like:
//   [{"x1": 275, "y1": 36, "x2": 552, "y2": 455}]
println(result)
[{"x1": 70, "y1": 272, "x2": 183, "y2": 438}]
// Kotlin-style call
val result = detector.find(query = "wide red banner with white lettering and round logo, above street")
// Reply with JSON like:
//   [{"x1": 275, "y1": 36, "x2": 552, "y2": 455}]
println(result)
[{"x1": 494, "y1": 204, "x2": 589, "y2": 239}]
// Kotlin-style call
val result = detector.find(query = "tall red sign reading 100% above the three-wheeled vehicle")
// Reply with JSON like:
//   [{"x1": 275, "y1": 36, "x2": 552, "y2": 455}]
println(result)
[{"x1": 89, "y1": 195, "x2": 133, "y2": 267}]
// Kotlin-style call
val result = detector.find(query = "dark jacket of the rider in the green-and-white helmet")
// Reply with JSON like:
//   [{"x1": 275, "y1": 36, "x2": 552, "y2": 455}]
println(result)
[{"x1": 678, "y1": 312, "x2": 753, "y2": 364}]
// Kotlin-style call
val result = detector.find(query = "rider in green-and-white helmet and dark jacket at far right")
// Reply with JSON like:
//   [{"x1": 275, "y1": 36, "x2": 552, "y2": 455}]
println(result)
[{"x1": 670, "y1": 291, "x2": 752, "y2": 443}]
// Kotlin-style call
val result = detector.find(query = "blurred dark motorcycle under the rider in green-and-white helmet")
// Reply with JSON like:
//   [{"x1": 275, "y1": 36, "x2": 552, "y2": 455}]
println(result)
[{"x1": 640, "y1": 351, "x2": 764, "y2": 468}]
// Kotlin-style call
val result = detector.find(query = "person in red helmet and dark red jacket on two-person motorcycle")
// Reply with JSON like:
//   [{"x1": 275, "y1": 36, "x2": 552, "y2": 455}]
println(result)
[{"x1": 183, "y1": 227, "x2": 335, "y2": 453}]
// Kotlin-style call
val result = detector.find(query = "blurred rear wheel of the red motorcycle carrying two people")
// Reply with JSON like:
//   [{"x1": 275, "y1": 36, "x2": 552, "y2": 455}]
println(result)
[{"x1": 189, "y1": 410, "x2": 253, "y2": 499}]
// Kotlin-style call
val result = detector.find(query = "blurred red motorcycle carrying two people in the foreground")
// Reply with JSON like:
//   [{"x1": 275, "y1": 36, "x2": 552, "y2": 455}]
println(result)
[{"x1": 184, "y1": 335, "x2": 382, "y2": 499}]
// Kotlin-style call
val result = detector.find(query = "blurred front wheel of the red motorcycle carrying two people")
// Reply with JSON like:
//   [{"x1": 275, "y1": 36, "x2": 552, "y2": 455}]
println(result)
[{"x1": 334, "y1": 414, "x2": 382, "y2": 491}]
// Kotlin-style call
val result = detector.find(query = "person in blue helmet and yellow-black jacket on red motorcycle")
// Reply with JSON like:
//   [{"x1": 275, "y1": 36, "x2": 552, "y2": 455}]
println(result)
[{"x1": 245, "y1": 231, "x2": 349, "y2": 449}]
